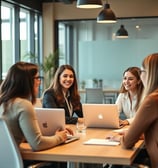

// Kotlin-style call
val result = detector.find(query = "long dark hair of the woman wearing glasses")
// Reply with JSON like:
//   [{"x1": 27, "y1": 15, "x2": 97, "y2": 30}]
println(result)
[{"x1": 0, "y1": 62, "x2": 38, "y2": 105}]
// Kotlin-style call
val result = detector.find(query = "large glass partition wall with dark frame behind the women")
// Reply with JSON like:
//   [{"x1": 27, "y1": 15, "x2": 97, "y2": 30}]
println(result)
[{"x1": 58, "y1": 18, "x2": 158, "y2": 89}]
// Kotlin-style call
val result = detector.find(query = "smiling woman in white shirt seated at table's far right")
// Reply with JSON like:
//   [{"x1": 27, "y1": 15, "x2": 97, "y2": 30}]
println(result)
[{"x1": 116, "y1": 67, "x2": 144, "y2": 125}]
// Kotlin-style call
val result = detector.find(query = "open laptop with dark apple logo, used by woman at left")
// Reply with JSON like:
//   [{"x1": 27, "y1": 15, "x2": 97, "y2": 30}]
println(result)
[{"x1": 35, "y1": 107, "x2": 79, "y2": 143}]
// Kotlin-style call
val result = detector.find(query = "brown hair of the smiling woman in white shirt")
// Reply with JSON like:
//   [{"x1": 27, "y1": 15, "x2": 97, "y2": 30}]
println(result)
[{"x1": 120, "y1": 67, "x2": 144, "y2": 110}]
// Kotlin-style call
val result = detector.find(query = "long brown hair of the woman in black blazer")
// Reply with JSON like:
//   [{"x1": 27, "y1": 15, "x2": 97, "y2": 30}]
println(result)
[{"x1": 45, "y1": 65, "x2": 80, "y2": 110}]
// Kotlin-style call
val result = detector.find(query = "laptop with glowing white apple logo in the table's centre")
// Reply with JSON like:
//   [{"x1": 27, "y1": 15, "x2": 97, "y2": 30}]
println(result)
[{"x1": 82, "y1": 104, "x2": 121, "y2": 128}]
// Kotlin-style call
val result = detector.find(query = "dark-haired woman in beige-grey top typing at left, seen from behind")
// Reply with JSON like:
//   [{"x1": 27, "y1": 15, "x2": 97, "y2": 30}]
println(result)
[{"x1": 0, "y1": 62, "x2": 72, "y2": 151}]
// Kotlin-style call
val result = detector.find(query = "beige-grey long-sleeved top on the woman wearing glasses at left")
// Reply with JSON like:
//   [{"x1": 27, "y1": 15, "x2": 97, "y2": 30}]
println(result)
[{"x1": 0, "y1": 98, "x2": 62, "y2": 151}]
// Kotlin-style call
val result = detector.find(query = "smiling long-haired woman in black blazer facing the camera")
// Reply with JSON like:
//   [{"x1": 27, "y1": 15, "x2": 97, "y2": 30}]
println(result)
[{"x1": 43, "y1": 65, "x2": 83, "y2": 124}]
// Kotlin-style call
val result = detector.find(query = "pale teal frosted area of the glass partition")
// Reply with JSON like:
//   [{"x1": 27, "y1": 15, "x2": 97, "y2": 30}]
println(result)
[{"x1": 79, "y1": 39, "x2": 158, "y2": 88}]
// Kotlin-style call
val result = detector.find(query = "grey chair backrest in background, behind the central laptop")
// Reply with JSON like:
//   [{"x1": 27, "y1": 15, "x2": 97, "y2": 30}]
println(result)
[{"x1": 85, "y1": 88, "x2": 104, "y2": 104}]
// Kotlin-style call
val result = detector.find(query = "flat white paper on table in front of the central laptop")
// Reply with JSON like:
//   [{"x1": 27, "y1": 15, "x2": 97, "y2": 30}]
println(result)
[{"x1": 83, "y1": 139, "x2": 120, "y2": 146}]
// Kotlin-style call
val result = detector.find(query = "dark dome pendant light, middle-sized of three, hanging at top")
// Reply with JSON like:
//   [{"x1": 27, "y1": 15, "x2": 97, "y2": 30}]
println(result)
[{"x1": 97, "y1": 1, "x2": 117, "y2": 23}]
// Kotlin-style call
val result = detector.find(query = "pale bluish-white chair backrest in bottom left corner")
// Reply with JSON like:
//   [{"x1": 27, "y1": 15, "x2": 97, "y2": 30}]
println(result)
[{"x1": 0, "y1": 117, "x2": 24, "y2": 168}]
